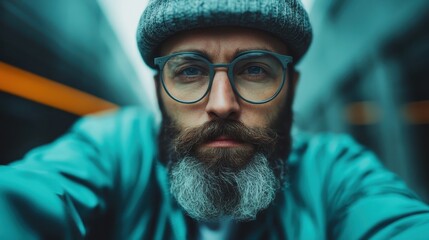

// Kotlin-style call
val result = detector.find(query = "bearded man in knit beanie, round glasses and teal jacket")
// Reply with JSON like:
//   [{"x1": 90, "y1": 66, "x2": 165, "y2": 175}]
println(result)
[{"x1": 0, "y1": 0, "x2": 429, "y2": 239}]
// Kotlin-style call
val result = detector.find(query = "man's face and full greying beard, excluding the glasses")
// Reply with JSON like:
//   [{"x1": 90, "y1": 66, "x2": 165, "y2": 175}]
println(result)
[{"x1": 158, "y1": 28, "x2": 292, "y2": 221}]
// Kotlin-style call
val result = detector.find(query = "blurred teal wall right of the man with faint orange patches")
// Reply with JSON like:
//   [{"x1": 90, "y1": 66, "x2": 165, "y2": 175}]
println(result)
[{"x1": 295, "y1": 0, "x2": 429, "y2": 201}]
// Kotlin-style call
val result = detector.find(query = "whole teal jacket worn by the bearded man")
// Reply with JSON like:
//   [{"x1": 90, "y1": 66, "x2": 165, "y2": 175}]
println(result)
[{"x1": 0, "y1": 108, "x2": 429, "y2": 240}]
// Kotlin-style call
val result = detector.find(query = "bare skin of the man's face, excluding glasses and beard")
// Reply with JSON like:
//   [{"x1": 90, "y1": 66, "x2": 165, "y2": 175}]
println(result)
[{"x1": 159, "y1": 27, "x2": 297, "y2": 134}]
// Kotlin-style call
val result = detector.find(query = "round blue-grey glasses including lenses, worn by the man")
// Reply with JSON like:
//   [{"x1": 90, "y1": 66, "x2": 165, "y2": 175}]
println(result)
[{"x1": 154, "y1": 50, "x2": 292, "y2": 104}]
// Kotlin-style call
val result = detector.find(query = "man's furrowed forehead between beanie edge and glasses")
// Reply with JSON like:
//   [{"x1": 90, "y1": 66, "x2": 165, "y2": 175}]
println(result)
[{"x1": 159, "y1": 27, "x2": 288, "y2": 61}]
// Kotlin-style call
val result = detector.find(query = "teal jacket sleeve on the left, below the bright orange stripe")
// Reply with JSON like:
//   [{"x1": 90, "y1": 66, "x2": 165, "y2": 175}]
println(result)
[{"x1": 0, "y1": 110, "x2": 155, "y2": 239}]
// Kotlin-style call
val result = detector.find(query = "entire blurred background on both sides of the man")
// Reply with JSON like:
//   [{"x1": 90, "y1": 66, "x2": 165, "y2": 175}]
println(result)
[{"x1": 0, "y1": 0, "x2": 429, "y2": 201}]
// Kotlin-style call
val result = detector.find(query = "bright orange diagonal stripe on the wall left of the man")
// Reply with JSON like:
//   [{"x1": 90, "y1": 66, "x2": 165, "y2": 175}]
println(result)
[{"x1": 0, "y1": 62, "x2": 118, "y2": 116}]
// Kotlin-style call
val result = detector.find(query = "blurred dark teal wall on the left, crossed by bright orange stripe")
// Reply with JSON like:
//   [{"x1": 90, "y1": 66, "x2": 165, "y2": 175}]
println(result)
[{"x1": 0, "y1": 0, "x2": 142, "y2": 164}]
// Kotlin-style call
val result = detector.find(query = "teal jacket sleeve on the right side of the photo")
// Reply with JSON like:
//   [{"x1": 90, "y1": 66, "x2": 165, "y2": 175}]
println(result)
[{"x1": 316, "y1": 136, "x2": 429, "y2": 239}]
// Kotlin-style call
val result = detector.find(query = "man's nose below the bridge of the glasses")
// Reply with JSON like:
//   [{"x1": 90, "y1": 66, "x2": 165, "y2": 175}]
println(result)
[{"x1": 205, "y1": 71, "x2": 240, "y2": 119}]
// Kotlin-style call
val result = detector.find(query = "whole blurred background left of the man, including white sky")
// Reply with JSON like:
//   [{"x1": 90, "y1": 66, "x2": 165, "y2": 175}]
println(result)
[{"x1": 0, "y1": 0, "x2": 155, "y2": 164}]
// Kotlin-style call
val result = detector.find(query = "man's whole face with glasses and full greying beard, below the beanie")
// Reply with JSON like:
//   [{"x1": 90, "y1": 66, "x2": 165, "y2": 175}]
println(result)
[{"x1": 155, "y1": 27, "x2": 297, "y2": 221}]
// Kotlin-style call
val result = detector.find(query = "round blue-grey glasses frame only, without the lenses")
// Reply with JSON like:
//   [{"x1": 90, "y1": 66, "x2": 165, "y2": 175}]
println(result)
[{"x1": 154, "y1": 50, "x2": 293, "y2": 104}]
